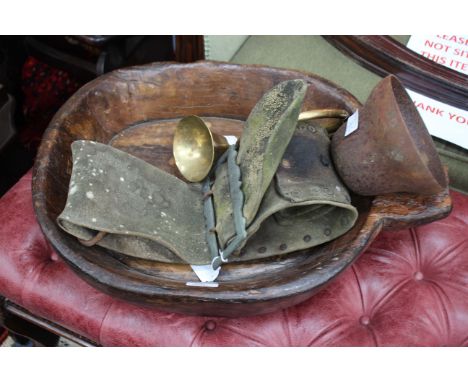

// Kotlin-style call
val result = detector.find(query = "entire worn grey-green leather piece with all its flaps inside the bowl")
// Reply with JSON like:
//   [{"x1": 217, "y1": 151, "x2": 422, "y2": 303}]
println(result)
[{"x1": 57, "y1": 80, "x2": 358, "y2": 265}]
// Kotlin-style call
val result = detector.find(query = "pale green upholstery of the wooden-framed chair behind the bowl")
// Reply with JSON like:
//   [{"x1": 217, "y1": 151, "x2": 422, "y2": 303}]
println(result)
[{"x1": 231, "y1": 35, "x2": 468, "y2": 194}]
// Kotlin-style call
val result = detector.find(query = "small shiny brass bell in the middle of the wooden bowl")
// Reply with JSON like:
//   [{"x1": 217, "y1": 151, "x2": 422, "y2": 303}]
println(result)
[{"x1": 172, "y1": 115, "x2": 229, "y2": 182}]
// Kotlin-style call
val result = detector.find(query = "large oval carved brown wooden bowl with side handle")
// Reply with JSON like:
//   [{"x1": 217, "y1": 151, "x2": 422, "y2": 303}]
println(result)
[{"x1": 33, "y1": 62, "x2": 451, "y2": 316}]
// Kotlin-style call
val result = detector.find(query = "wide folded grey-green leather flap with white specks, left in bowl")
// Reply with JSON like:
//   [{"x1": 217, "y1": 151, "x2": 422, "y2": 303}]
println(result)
[{"x1": 57, "y1": 141, "x2": 210, "y2": 264}]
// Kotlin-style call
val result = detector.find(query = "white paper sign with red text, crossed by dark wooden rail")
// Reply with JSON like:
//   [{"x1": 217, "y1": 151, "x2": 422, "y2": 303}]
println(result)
[{"x1": 407, "y1": 35, "x2": 468, "y2": 149}]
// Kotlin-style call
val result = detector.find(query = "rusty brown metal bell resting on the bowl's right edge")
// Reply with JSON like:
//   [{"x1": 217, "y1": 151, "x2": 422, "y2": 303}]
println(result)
[{"x1": 331, "y1": 76, "x2": 447, "y2": 195}]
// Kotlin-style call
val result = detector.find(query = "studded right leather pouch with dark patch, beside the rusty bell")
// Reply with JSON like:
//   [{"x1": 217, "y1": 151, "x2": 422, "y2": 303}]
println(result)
[{"x1": 225, "y1": 121, "x2": 358, "y2": 260}]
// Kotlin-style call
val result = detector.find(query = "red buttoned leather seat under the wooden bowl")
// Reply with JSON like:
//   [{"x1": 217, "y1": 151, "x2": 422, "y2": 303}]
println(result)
[{"x1": 0, "y1": 173, "x2": 468, "y2": 346}]
